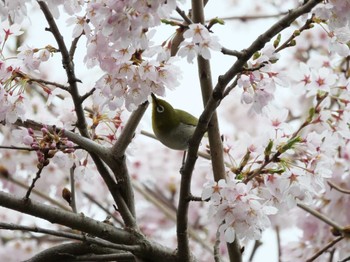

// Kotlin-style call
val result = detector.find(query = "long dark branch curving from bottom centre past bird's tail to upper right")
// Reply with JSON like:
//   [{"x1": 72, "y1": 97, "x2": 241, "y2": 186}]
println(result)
[{"x1": 177, "y1": 0, "x2": 322, "y2": 258}]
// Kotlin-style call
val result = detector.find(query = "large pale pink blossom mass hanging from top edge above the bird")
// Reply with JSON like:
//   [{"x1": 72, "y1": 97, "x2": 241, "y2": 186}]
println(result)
[{"x1": 75, "y1": 0, "x2": 183, "y2": 111}]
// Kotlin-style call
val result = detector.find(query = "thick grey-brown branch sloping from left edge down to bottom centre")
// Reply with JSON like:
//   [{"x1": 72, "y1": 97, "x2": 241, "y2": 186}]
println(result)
[{"x1": 0, "y1": 191, "x2": 175, "y2": 262}]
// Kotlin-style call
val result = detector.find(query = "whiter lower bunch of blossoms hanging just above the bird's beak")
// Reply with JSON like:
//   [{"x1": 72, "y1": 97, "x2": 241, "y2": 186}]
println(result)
[{"x1": 93, "y1": 56, "x2": 179, "y2": 111}]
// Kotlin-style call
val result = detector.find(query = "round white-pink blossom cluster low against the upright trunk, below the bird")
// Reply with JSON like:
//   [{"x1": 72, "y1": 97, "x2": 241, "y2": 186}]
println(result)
[{"x1": 202, "y1": 178, "x2": 277, "y2": 243}]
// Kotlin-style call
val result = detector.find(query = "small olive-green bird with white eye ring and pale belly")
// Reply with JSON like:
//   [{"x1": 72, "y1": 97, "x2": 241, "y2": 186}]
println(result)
[{"x1": 151, "y1": 93, "x2": 198, "y2": 150}]
